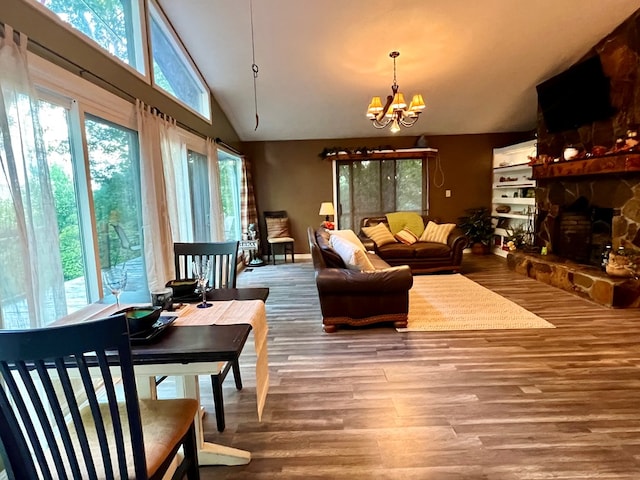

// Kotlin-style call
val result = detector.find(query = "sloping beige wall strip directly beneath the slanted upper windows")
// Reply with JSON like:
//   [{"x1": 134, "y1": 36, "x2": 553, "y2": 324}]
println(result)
[{"x1": 0, "y1": 0, "x2": 240, "y2": 147}]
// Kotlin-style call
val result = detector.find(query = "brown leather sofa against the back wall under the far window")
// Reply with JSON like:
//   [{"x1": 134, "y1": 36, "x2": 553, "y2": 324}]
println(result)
[{"x1": 358, "y1": 216, "x2": 467, "y2": 274}]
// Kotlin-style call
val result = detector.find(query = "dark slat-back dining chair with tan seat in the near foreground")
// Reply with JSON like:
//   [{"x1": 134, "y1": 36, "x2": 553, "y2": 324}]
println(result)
[{"x1": 0, "y1": 314, "x2": 200, "y2": 480}]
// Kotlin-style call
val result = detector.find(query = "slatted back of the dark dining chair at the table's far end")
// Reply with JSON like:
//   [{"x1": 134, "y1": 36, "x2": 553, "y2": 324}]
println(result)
[{"x1": 173, "y1": 241, "x2": 240, "y2": 288}]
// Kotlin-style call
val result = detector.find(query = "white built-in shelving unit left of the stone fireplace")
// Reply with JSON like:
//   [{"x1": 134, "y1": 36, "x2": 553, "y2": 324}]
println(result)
[{"x1": 492, "y1": 140, "x2": 536, "y2": 257}]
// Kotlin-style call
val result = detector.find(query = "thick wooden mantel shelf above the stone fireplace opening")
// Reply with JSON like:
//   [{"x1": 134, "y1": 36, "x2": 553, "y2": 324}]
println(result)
[{"x1": 533, "y1": 153, "x2": 640, "y2": 180}]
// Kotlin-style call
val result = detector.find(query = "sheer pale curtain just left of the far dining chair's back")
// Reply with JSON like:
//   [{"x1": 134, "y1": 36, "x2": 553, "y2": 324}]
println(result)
[{"x1": 136, "y1": 100, "x2": 180, "y2": 291}]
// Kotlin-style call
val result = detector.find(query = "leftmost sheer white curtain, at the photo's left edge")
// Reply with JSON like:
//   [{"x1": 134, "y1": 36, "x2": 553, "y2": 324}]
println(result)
[{"x1": 0, "y1": 25, "x2": 67, "y2": 328}]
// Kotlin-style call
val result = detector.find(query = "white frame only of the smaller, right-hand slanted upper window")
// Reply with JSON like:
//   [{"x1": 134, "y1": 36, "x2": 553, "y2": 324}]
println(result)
[{"x1": 146, "y1": 0, "x2": 213, "y2": 123}]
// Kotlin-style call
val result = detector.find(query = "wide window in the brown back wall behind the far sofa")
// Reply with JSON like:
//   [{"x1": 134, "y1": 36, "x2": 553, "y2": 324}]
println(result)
[{"x1": 336, "y1": 155, "x2": 428, "y2": 230}]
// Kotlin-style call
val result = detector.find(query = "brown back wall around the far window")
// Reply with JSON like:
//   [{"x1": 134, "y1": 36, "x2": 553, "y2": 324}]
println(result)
[{"x1": 242, "y1": 132, "x2": 531, "y2": 253}]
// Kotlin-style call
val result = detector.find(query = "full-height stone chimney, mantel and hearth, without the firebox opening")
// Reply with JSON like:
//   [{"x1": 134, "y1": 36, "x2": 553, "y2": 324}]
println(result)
[{"x1": 507, "y1": 10, "x2": 640, "y2": 307}]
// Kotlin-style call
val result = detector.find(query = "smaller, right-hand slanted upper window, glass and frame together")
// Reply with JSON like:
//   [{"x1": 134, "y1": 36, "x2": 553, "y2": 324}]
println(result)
[{"x1": 149, "y1": 1, "x2": 211, "y2": 120}]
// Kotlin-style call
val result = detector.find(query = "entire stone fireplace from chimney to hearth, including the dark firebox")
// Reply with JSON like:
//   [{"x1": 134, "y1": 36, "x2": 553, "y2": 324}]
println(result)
[{"x1": 507, "y1": 10, "x2": 640, "y2": 308}]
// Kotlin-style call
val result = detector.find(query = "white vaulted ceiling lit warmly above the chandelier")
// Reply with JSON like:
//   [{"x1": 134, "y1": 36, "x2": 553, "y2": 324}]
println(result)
[{"x1": 160, "y1": 0, "x2": 640, "y2": 141}]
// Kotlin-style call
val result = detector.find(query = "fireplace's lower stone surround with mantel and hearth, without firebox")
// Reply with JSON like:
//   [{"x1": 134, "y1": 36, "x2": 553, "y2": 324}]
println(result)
[{"x1": 507, "y1": 153, "x2": 640, "y2": 308}]
